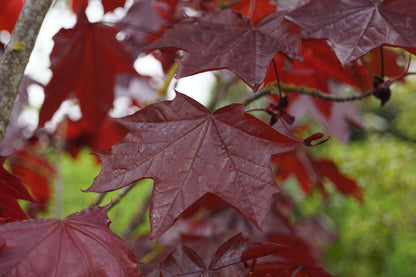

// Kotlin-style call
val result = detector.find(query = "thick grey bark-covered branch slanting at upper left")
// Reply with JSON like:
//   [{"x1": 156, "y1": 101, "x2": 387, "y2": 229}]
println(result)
[{"x1": 0, "y1": 0, "x2": 52, "y2": 144}]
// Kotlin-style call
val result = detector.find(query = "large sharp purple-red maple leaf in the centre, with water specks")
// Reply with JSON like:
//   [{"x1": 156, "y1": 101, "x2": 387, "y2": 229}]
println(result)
[{"x1": 87, "y1": 93, "x2": 300, "y2": 236}]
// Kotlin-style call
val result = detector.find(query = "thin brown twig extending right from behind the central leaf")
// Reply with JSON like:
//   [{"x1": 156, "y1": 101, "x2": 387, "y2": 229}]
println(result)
[{"x1": 244, "y1": 83, "x2": 374, "y2": 105}]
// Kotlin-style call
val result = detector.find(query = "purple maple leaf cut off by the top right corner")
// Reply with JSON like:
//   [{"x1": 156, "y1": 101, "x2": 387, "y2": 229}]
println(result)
[{"x1": 289, "y1": 0, "x2": 416, "y2": 64}]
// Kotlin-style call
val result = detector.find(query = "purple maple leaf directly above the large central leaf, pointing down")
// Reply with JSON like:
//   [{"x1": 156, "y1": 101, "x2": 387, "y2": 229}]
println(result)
[{"x1": 148, "y1": 10, "x2": 300, "y2": 91}]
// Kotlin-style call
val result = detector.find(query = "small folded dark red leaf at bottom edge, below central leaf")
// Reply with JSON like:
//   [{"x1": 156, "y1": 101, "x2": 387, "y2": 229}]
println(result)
[{"x1": 160, "y1": 233, "x2": 290, "y2": 277}]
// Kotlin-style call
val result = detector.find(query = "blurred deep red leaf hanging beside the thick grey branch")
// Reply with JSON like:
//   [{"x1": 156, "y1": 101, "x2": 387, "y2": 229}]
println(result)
[{"x1": 39, "y1": 12, "x2": 136, "y2": 129}]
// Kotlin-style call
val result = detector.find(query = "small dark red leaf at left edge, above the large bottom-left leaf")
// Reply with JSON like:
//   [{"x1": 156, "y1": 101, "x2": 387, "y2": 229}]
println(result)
[{"x1": 0, "y1": 157, "x2": 35, "y2": 220}]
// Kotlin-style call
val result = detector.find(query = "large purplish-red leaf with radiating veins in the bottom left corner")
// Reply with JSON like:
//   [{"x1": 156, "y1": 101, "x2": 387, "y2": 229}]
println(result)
[{"x1": 0, "y1": 206, "x2": 141, "y2": 276}]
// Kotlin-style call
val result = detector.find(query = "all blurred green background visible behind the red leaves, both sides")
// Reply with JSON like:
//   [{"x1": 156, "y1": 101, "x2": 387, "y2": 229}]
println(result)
[{"x1": 39, "y1": 80, "x2": 416, "y2": 277}]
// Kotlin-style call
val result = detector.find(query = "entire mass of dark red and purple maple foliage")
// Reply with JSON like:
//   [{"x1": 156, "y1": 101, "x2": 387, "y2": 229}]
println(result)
[{"x1": 0, "y1": 0, "x2": 416, "y2": 277}]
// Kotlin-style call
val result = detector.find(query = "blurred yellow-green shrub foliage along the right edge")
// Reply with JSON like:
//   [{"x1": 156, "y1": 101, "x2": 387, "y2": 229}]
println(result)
[{"x1": 292, "y1": 78, "x2": 416, "y2": 277}]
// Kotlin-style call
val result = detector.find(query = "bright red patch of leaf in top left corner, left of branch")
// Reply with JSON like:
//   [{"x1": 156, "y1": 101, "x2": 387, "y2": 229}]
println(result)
[{"x1": 0, "y1": 0, "x2": 25, "y2": 33}]
